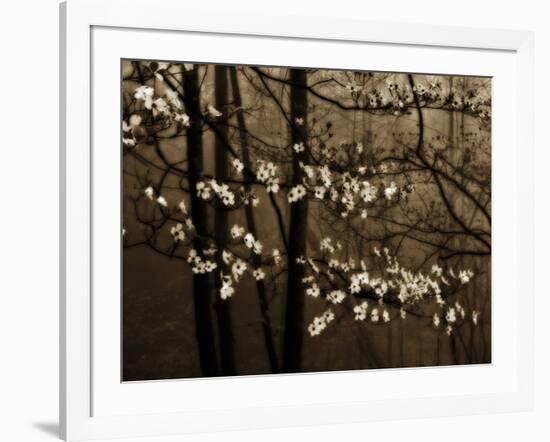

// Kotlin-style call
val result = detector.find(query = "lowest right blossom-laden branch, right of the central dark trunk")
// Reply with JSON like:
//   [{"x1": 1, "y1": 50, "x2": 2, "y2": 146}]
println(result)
[{"x1": 300, "y1": 243, "x2": 480, "y2": 336}]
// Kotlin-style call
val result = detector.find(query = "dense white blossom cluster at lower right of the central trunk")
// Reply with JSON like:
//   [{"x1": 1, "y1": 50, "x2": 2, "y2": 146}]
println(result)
[{"x1": 297, "y1": 237, "x2": 479, "y2": 336}]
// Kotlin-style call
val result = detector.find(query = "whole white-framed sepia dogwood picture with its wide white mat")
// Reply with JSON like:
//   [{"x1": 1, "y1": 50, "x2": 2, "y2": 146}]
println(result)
[{"x1": 60, "y1": 0, "x2": 533, "y2": 440}]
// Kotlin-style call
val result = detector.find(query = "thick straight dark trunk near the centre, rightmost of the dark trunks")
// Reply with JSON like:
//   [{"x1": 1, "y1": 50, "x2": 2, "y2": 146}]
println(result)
[{"x1": 283, "y1": 69, "x2": 309, "y2": 372}]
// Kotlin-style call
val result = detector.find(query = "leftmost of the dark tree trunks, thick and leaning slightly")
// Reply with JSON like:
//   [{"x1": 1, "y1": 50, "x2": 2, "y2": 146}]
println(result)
[{"x1": 183, "y1": 68, "x2": 218, "y2": 376}]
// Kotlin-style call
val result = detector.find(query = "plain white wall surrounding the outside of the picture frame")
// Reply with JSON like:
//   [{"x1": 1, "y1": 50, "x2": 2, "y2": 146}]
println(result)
[{"x1": 0, "y1": 0, "x2": 550, "y2": 442}]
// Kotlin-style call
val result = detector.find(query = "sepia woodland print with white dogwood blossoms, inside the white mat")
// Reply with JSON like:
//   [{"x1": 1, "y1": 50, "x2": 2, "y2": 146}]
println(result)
[{"x1": 120, "y1": 60, "x2": 492, "y2": 381}]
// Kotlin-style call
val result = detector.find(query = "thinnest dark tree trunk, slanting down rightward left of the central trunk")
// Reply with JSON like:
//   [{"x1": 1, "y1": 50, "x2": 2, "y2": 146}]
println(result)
[{"x1": 230, "y1": 67, "x2": 279, "y2": 373}]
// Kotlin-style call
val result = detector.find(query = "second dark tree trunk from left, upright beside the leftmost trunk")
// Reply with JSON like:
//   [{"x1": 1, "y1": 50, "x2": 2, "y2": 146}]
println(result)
[{"x1": 214, "y1": 65, "x2": 236, "y2": 376}]
